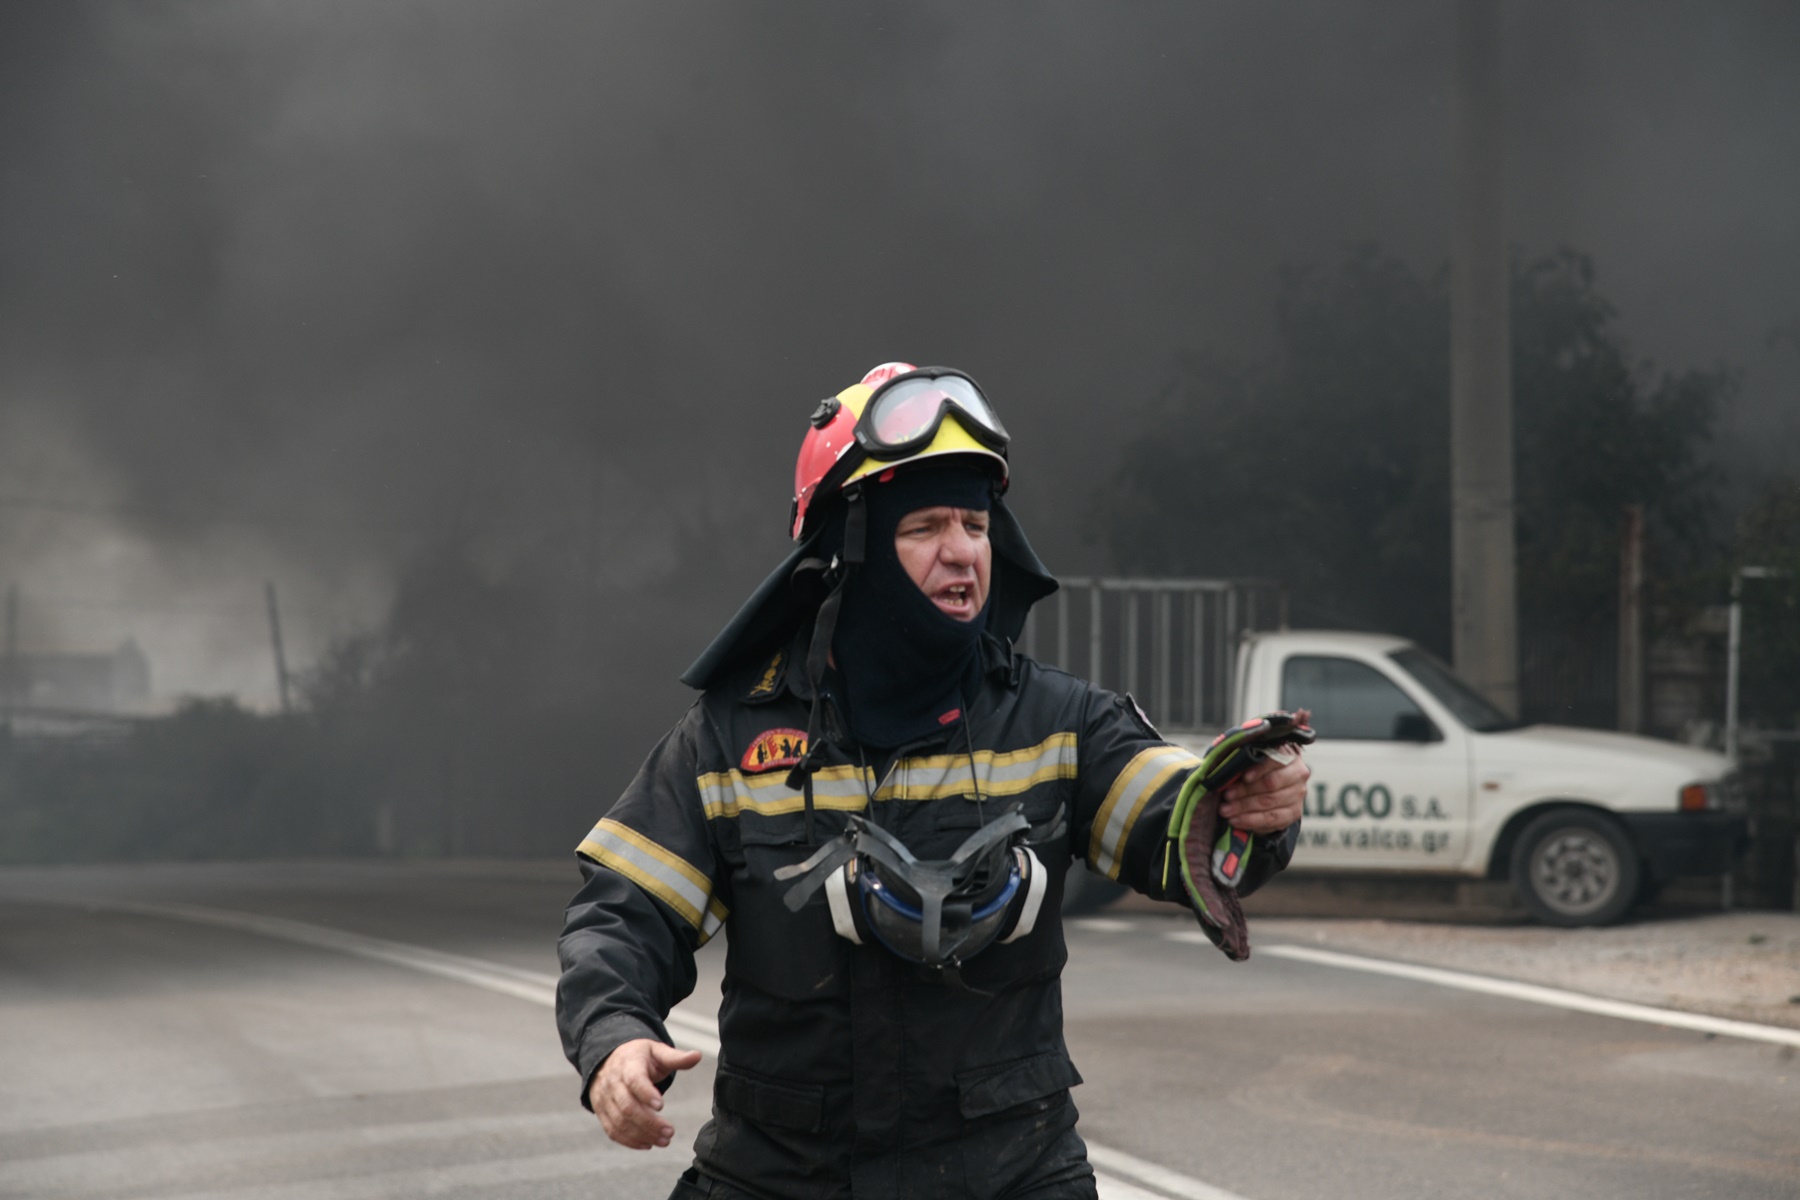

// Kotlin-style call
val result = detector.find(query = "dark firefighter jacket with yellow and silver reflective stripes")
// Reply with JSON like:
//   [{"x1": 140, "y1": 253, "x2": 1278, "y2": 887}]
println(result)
[{"x1": 556, "y1": 639, "x2": 1294, "y2": 1200}]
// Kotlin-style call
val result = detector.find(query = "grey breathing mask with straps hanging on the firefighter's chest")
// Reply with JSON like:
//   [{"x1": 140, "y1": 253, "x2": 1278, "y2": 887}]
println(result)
[{"x1": 774, "y1": 806, "x2": 1060, "y2": 990}]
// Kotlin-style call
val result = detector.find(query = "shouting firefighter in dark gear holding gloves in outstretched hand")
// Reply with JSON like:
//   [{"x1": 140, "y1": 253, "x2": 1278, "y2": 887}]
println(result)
[{"x1": 556, "y1": 363, "x2": 1307, "y2": 1200}]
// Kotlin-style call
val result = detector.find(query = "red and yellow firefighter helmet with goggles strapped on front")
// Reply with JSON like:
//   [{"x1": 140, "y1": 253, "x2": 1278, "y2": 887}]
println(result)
[{"x1": 790, "y1": 362, "x2": 1008, "y2": 542}]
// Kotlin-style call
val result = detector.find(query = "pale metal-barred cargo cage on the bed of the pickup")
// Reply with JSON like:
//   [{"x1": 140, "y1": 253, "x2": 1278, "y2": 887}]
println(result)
[{"x1": 1019, "y1": 576, "x2": 1287, "y2": 732}]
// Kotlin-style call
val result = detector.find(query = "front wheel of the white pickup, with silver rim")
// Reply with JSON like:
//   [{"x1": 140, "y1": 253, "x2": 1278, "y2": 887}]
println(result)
[{"x1": 1512, "y1": 808, "x2": 1642, "y2": 928}]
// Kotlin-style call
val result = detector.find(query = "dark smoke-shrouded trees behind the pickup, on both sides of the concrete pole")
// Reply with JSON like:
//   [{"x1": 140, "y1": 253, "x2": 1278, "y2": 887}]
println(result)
[{"x1": 1094, "y1": 246, "x2": 1735, "y2": 705}]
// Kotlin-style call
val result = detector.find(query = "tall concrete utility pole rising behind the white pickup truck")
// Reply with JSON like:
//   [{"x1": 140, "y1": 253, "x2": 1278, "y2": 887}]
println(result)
[{"x1": 1451, "y1": 0, "x2": 1519, "y2": 716}]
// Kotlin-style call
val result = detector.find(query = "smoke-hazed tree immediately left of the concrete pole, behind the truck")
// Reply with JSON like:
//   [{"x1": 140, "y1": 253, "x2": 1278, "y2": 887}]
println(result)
[{"x1": 1096, "y1": 246, "x2": 1449, "y2": 644}]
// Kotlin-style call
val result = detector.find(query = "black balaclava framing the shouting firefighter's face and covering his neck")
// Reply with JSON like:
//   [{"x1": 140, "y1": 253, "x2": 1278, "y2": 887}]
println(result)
[{"x1": 832, "y1": 461, "x2": 994, "y2": 748}]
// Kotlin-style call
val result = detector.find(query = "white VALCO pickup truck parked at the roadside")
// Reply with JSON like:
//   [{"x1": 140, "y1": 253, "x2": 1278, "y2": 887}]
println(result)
[{"x1": 1172, "y1": 630, "x2": 1746, "y2": 925}]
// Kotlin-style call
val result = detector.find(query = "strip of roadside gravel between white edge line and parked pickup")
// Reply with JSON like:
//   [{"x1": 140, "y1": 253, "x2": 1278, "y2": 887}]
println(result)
[{"x1": 1251, "y1": 912, "x2": 1800, "y2": 1029}]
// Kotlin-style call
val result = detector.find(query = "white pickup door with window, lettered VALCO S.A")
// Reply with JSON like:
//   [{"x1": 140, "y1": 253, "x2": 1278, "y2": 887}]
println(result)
[{"x1": 1282, "y1": 655, "x2": 1469, "y2": 871}]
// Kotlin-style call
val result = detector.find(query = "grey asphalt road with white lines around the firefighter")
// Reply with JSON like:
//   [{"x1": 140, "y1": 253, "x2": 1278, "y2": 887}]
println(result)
[{"x1": 0, "y1": 864, "x2": 1800, "y2": 1200}]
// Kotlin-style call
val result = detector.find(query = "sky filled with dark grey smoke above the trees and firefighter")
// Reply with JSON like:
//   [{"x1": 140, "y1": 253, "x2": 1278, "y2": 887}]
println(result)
[{"x1": 0, "y1": 0, "x2": 1800, "y2": 700}]
